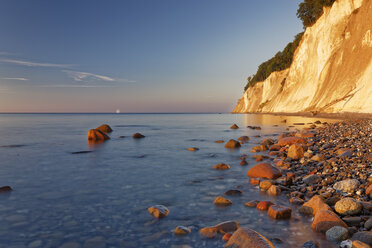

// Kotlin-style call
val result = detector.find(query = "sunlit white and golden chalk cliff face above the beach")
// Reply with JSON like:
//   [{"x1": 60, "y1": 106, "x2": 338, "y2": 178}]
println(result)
[{"x1": 233, "y1": 0, "x2": 372, "y2": 113}]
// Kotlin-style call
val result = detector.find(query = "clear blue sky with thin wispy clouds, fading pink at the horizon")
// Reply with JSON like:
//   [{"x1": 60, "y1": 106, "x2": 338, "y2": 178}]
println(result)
[{"x1": 0, "y1": 0, "x2": 303, "y2": 113}]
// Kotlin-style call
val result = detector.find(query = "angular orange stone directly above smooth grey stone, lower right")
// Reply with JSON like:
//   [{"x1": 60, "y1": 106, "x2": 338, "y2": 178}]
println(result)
[{"x1": 311, "y1": 210, "x2": 347, "y2": 233}]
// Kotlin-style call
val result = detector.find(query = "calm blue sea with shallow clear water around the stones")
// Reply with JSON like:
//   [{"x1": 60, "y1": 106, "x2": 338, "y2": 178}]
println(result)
[{"x1": 0, "y1": 114, "x2": 342, "y2": 248}]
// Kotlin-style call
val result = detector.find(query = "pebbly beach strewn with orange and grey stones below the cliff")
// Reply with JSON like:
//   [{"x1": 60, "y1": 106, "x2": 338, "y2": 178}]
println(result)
[{"x1": 226, "y1": 120, "x2": 372, "y2": 248}]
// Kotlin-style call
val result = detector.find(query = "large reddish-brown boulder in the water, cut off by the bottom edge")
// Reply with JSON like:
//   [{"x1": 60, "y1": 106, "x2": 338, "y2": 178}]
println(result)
[{"x1": 225, "y1": 227, "x2": 275, "y2": 248}]
